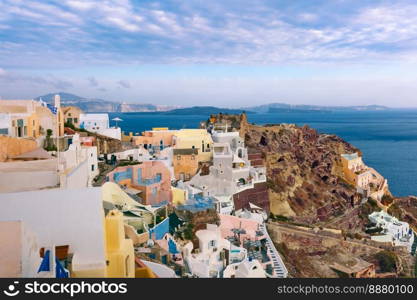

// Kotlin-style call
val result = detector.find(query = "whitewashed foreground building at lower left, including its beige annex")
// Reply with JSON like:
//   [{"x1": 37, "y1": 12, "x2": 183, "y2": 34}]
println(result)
[{"x1": 0, "y1": 188, "x2": 106, "y2": 276}]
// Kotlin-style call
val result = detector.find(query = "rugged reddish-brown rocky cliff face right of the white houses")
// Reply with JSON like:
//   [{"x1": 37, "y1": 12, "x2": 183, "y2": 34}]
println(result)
[{"x1": 208, "y1": 114, "x2": 370, "y2": 226}]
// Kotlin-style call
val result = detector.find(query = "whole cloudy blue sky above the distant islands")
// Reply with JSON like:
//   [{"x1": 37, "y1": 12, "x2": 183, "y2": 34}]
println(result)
[{"x1": 0, "y1": 0, "x2": 417, "y2": 107}]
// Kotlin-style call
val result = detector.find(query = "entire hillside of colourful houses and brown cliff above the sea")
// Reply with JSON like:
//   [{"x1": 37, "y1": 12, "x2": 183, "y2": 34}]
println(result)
[{"x1": 0, "y1": 95, "x2": 417, "y2": 278}]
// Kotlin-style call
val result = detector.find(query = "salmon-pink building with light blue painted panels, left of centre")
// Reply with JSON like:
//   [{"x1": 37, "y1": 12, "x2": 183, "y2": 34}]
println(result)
[{"x1": 107, "y1": 161, "x2": 172, "y2": 206}]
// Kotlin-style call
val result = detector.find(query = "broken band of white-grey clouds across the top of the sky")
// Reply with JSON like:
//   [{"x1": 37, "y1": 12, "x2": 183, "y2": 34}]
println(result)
[{"x1": 0, "y1": 0, "x2": 417, "y2": 66}]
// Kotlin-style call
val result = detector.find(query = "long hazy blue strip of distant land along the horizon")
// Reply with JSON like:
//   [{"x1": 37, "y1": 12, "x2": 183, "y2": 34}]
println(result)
[{"x1": 34, "y1": 92, "x2": 393, "y2": 115}]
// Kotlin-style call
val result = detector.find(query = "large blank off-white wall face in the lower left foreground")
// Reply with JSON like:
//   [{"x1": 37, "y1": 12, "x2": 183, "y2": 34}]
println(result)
[{"x1": 0, "y1": 188, "x2": 105, "y2": 269}]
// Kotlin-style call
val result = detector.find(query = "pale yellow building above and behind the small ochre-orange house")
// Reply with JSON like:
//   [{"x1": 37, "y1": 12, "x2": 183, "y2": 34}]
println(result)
[{"x1": 173, "y1": 129, "x2": 213, "y2": 162}]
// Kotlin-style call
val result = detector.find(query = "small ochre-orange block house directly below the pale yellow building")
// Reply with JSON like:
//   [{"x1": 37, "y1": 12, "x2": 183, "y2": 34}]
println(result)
[{"x1": 172, "y1": 148, "x2": 198, "y2": 181}]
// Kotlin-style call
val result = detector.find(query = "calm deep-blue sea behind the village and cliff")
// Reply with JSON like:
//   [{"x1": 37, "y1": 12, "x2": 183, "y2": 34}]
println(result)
[{"x1": 110, "y1": 110, "x2": 417, "y2": 196}]
